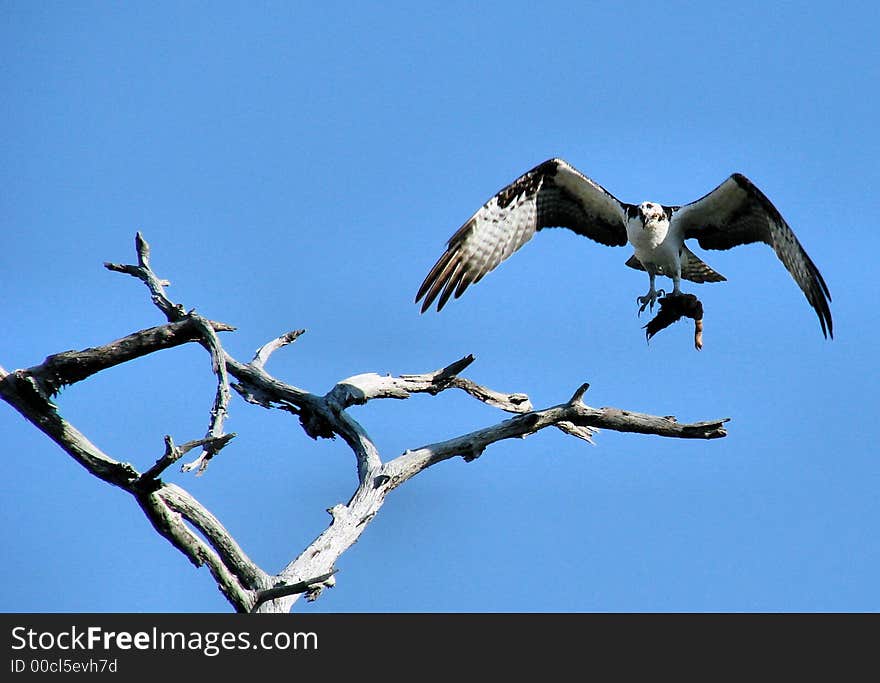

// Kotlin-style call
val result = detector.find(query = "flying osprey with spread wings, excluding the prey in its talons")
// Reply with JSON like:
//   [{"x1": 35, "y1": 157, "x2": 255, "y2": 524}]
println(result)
[{"x1": 416, "y1": 159, "x2": 834, "y2": 338}]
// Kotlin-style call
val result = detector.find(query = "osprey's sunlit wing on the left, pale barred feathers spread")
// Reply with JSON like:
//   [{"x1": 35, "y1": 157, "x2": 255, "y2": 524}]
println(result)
[{"x1": 416, "y1": 159, "x2": 635, "y2": 313}]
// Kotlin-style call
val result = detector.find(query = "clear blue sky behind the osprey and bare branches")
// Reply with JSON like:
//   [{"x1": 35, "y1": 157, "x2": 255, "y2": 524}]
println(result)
[{"x1": 0, "y1": 2, "x2": 880, "y2": 612}]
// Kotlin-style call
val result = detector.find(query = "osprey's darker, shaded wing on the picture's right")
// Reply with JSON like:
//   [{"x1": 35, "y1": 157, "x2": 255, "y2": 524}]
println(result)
[{"x1": 673, "y1": 173, "x2": 834, "y2": 337}]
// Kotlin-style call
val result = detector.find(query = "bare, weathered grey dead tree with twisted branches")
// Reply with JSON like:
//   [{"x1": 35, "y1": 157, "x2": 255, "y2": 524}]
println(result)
[{"x1": 0, "y1": 234, "x2": 727, "y2": 612}]
